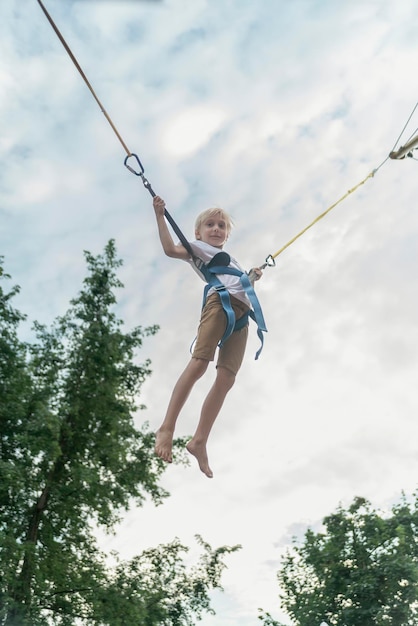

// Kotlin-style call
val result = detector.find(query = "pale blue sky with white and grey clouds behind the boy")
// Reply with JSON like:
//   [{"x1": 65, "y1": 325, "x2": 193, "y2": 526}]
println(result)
[{"x1": 0, "y1": 0, "x2": 418, "y2": 626}]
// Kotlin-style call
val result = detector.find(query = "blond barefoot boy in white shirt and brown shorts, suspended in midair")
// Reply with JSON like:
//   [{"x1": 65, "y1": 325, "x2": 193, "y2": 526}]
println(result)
[{"x1": 153, "y1": 196, "x2": 262, "y2": 478}]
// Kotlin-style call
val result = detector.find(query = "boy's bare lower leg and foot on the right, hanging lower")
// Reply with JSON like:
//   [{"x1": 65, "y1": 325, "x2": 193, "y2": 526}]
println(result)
[{"x1": 186, "y1": 367, "x2": 235, "y2": 478}]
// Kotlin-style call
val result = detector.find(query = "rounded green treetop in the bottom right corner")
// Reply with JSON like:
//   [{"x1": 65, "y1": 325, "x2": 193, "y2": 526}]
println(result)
[{"x1": 278, "y1": 496, "x2": 418, "y2": 626}]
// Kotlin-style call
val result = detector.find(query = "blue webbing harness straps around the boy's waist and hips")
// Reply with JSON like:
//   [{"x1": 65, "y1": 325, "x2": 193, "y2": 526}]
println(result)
[{"x1": 198, "y1": 252, "x2": 267, "y2": 359}]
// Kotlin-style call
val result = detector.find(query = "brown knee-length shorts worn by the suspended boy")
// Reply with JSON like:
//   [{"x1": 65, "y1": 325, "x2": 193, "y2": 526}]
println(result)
[{"x1": 192, "y1": 293, "x2": 248, "y2": 374}]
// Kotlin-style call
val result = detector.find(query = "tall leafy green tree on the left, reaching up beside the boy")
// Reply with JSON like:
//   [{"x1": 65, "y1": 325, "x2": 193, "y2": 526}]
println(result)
[{"x1": 0, "y1": 241, "x2": 240, "y2": 626}]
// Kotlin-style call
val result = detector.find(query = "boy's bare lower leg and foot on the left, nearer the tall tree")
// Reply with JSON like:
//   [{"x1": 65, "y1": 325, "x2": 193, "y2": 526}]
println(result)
[{"x1": 155, "y1": 357, "x2": 209, "y2": 463}]
